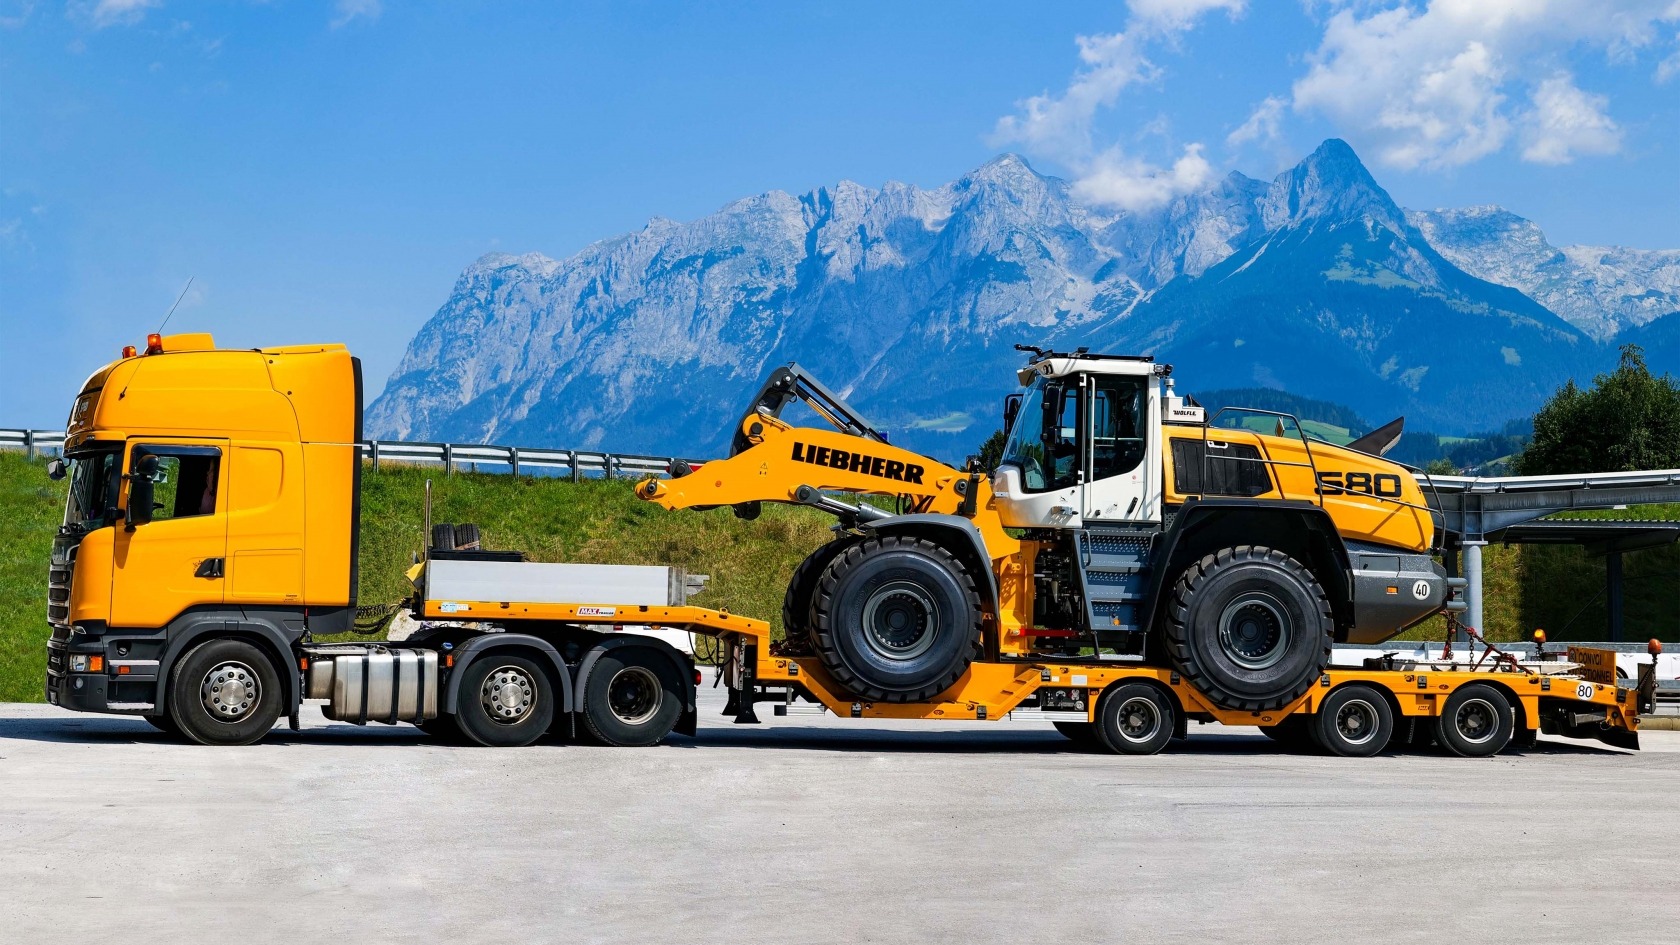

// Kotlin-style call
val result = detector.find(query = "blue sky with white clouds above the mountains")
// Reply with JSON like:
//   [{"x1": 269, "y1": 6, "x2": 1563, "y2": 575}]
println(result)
[{"x1": 0, "y1": 0, "x2": 1680, "y2": 427}]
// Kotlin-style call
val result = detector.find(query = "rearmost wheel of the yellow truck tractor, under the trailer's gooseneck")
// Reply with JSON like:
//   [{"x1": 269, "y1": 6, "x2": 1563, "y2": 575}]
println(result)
[{"x1": 583, "y1": 646, "x2": 685, "y2": 748}]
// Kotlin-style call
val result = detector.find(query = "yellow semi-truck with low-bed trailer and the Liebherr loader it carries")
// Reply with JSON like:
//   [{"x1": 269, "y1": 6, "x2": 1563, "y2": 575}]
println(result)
[{"x1": 45, "y1": 335, "x2": 1655, "y2": 755}]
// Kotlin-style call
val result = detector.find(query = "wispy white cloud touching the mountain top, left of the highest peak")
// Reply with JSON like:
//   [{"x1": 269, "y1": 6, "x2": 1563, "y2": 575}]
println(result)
[{"x1": 993, "y1": 0, "x2": 1247, "y2": 210}]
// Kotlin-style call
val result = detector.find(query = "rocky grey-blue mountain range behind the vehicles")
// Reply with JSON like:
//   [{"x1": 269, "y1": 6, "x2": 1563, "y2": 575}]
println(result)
[{"x1": 368, "y1": 140, "x2": 1680, "y2": 459}]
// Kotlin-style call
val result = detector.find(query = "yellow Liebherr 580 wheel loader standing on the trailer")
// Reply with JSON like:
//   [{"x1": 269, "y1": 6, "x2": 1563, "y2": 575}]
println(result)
[{"x1": 638, "y1": 348, "x2": 1457, "y2": 711}]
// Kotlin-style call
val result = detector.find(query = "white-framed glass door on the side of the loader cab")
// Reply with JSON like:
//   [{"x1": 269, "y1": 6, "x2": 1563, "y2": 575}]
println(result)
[{"x1": 1080, "y1": 373, "x2": 1161, "y2": 521}]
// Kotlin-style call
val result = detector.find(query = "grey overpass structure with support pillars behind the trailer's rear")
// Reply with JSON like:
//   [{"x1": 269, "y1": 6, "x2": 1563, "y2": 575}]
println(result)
[{"x1": 1416, "y1": 469, "x2": 1680, "y2": 641}]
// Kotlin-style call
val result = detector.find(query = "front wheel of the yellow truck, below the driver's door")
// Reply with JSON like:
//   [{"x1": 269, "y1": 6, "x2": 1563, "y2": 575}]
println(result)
[{"x1": 160, "y1": 639, "x2": 281, "y2": 745}]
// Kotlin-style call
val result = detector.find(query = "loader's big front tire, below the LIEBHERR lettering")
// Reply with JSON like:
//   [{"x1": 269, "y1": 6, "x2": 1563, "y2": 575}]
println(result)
[{"x1": 811, "y1": 535, "x2": 979, "y2": 703}]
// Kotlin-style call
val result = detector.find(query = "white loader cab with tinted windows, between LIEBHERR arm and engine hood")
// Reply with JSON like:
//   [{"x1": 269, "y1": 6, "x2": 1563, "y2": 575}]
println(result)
[{"x1": 993, "y1": 351, "x2": 1164, "y2": 528}]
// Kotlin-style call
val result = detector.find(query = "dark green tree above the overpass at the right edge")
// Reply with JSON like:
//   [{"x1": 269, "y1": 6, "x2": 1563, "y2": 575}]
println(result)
[{"x1": 1514, "y1": 345, "x2": 1680, "y2": 476}]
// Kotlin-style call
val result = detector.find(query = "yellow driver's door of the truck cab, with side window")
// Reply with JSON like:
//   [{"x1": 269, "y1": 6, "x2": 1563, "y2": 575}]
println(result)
[{"x1": 111, "y1": 439, "x2": 228, "y2": 627}]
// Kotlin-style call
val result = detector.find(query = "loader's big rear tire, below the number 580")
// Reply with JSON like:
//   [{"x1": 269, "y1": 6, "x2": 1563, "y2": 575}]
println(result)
[{"x1": 1166, "y1": 545, "x2": 1336, "y2": 711}]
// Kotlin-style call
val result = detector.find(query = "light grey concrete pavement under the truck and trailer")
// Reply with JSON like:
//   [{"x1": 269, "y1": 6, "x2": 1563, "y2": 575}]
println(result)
[{"x1": 0, "y1": 689, "x2": 1680, "y2": 945}]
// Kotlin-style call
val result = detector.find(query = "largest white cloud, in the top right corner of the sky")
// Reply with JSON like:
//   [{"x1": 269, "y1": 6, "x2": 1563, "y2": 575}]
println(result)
[{"x1": 1292, "y1": 0, "x2": 1680, "y2": 168}]
